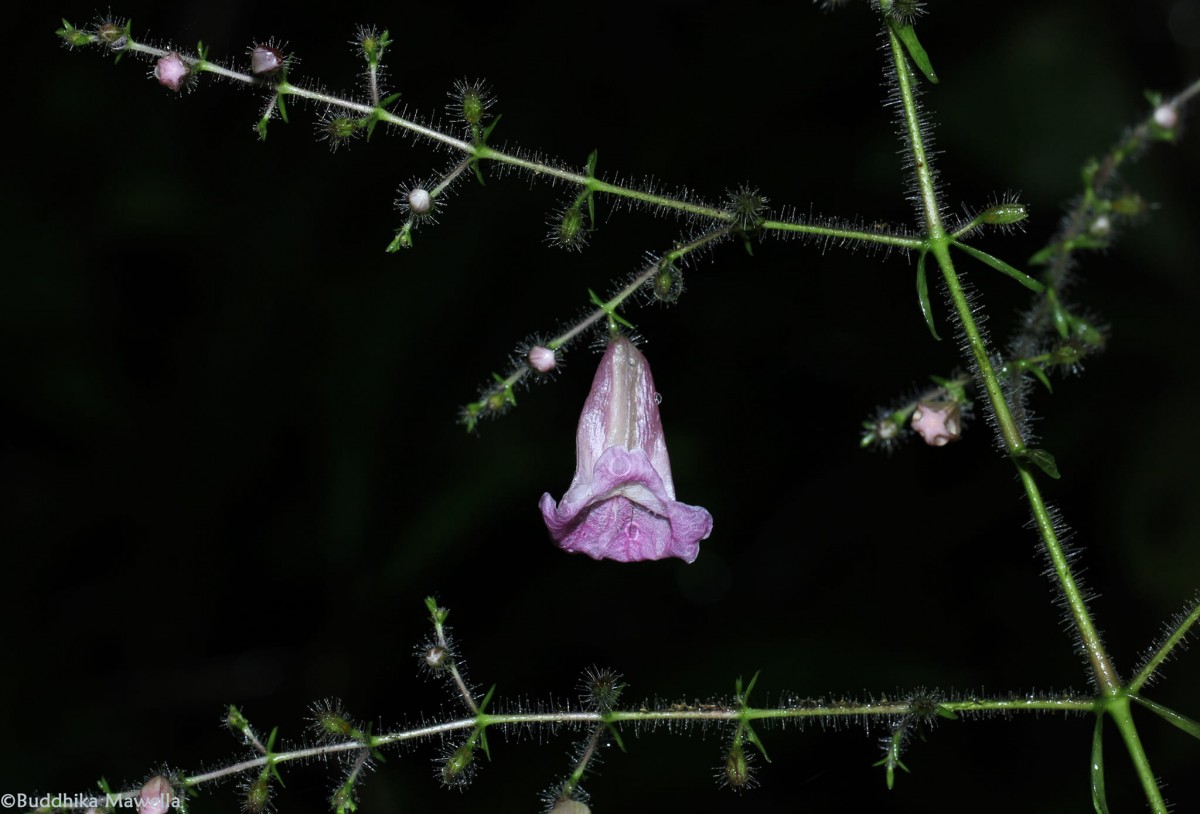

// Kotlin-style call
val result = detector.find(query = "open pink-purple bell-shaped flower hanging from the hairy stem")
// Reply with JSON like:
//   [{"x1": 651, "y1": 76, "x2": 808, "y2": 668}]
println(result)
[{"x1": 540, "y1": 336, "x2": 713, "y2": 562}]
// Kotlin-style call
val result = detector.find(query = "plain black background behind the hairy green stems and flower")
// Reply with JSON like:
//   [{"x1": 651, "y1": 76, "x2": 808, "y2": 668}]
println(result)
[{"x1": 0, "y1": 0, "x2": 1200, "y2": 813}]
